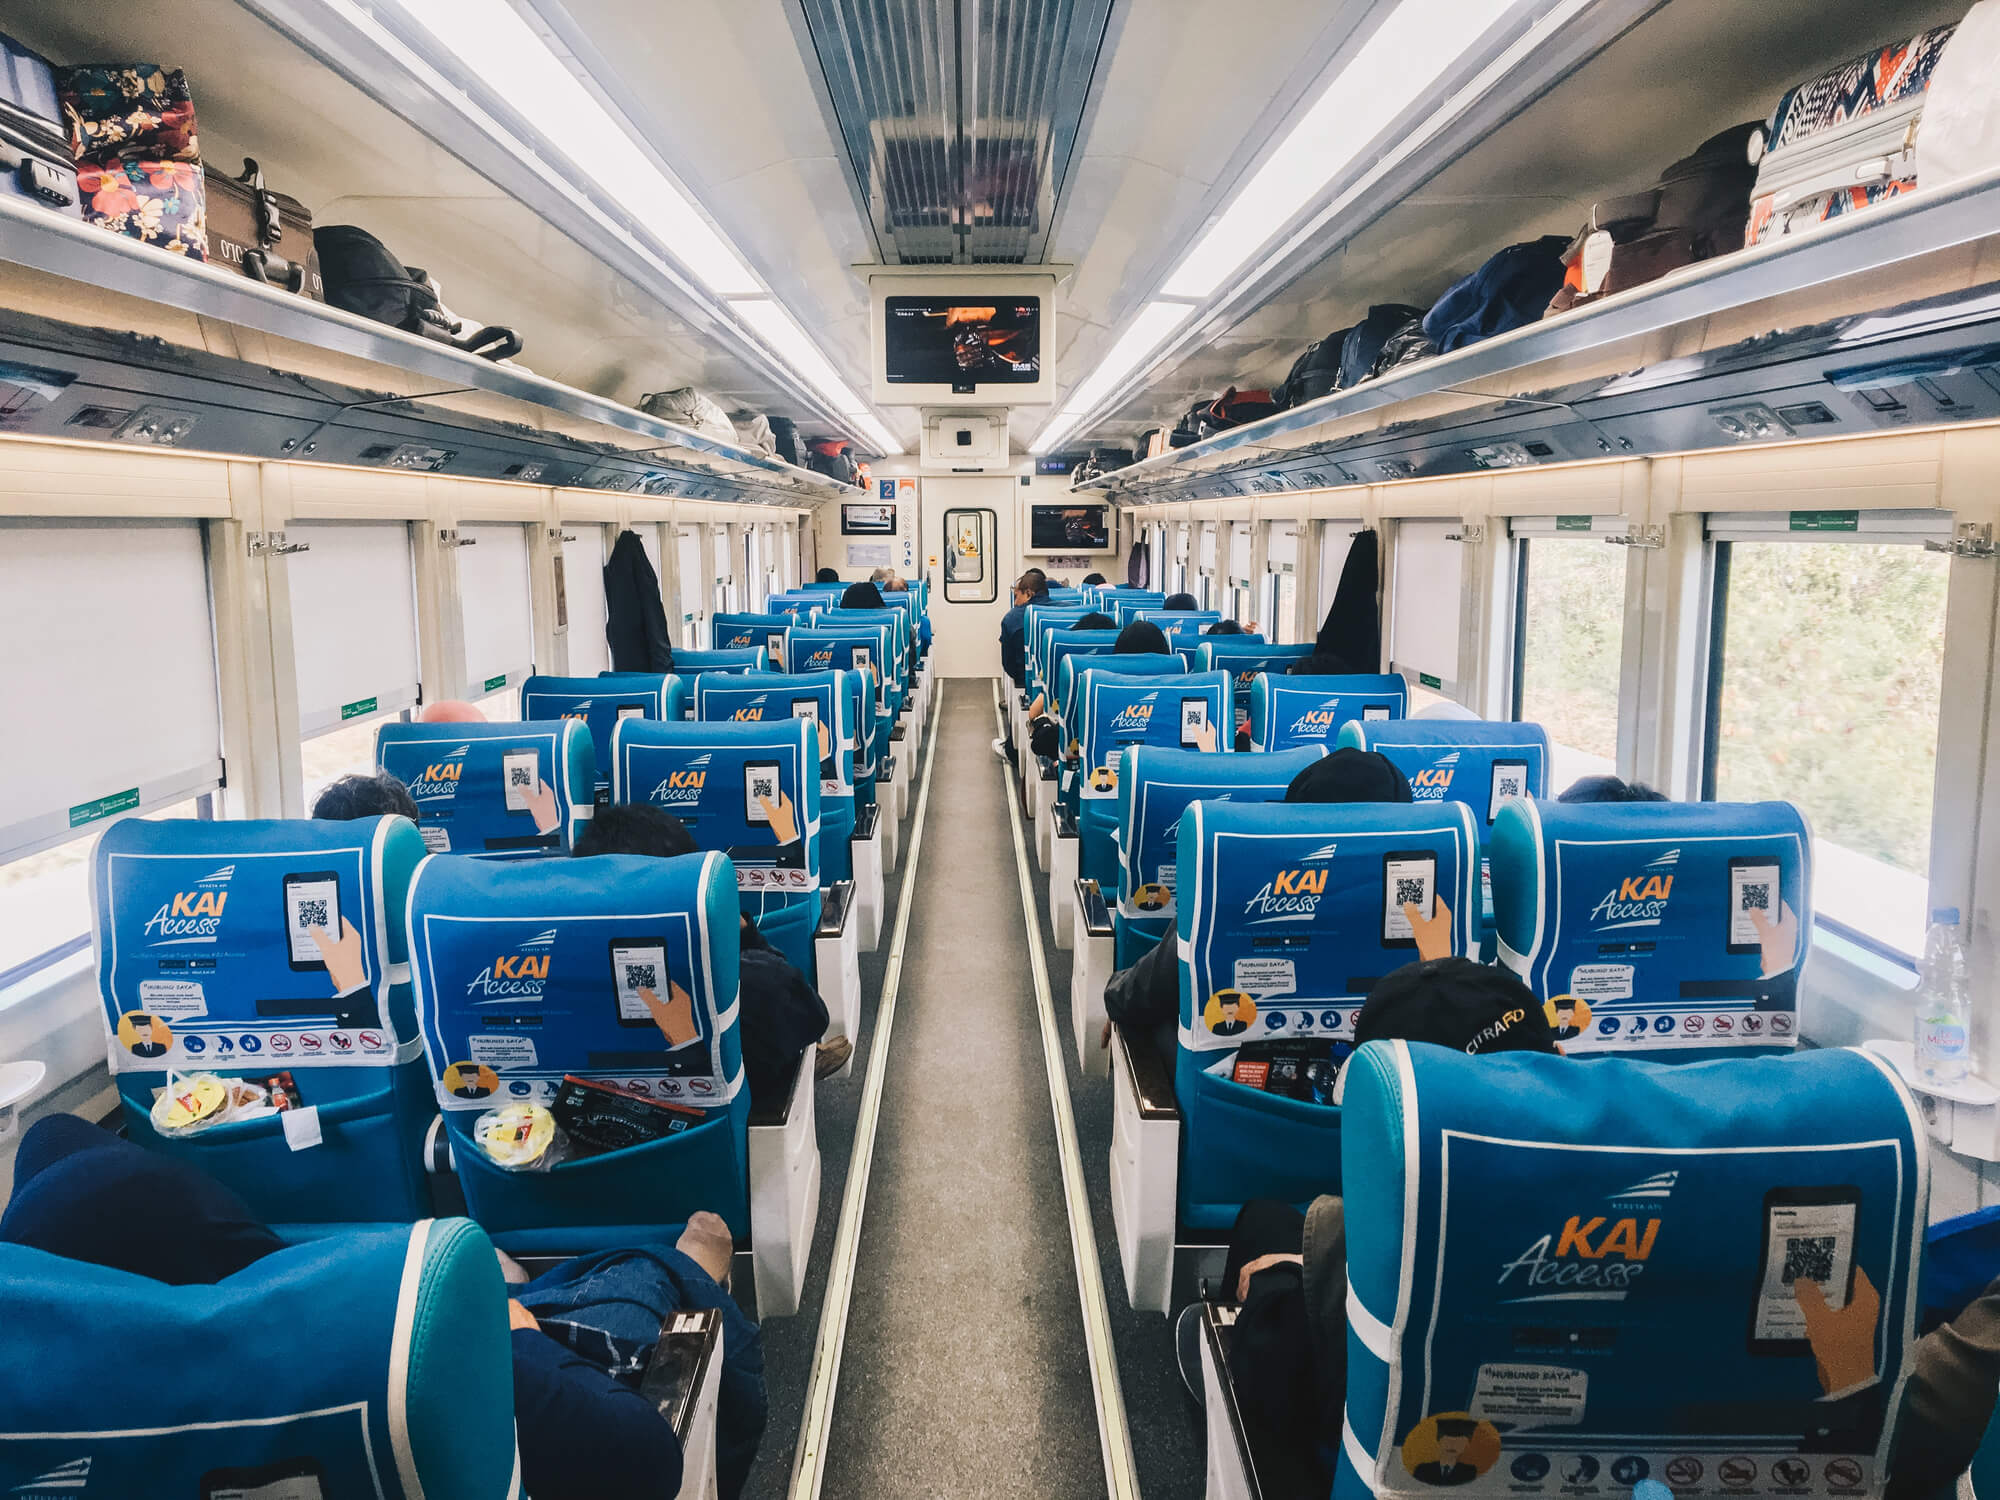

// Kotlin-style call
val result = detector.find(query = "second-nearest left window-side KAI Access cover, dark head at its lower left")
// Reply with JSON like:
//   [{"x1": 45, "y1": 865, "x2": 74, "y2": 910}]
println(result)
[{"x1": 376, "y1": 718, "x2": 598, "y2": 860}]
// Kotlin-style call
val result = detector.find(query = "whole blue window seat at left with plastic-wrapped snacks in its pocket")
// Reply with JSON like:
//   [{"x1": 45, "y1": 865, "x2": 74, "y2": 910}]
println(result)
[{"x1": 92, "y1": 816, "x2": 434, "y2": 1224}]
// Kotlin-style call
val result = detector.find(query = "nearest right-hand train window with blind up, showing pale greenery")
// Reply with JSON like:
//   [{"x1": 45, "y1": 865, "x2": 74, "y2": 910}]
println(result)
[{"x1": 1702, "y1": 512, "x2": 1950, "y2": 956}]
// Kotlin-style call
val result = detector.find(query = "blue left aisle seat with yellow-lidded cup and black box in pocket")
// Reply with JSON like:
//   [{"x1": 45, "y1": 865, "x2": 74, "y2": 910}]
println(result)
[{"x1": 410, "y1": 850, "x2": 820, "y2": 1316}]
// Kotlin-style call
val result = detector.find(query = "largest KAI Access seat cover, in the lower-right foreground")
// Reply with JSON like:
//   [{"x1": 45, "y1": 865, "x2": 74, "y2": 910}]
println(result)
[{"x1": 1334, "y1": 1042, "x2": 1928, "y2": 1500}]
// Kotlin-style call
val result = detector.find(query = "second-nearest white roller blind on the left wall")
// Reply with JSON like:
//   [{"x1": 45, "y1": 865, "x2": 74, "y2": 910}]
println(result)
[{"x1": 286, "y1": 520, "x2": 420, "y2": 738}]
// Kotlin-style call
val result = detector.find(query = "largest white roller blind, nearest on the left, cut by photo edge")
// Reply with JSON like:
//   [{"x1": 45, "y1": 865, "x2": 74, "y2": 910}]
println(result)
[{"x1": 0, "y1": 520, "x2": 222, "y2": 858}]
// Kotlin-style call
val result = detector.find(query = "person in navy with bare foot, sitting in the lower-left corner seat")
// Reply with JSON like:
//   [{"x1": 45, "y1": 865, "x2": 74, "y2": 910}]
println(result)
[{"x1": 0, "y1": 1114, "x2": 766, "y2": 1500}]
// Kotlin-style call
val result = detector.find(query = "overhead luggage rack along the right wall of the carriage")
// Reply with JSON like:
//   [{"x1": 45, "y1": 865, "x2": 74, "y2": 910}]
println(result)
[{"x1": 1076, "y1": 172, "x2": 2000, "y2": 504}]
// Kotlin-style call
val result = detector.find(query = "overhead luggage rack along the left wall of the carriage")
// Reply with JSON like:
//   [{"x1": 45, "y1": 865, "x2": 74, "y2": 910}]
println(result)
[{"x1": 0, "y1": 200, "x2": 856, "y2": 506}]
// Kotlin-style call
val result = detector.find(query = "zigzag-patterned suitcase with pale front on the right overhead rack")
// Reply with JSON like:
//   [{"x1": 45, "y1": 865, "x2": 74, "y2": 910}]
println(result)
[{"x1": 1744, "y1": 26, "x2": 1956, "y2": 244}]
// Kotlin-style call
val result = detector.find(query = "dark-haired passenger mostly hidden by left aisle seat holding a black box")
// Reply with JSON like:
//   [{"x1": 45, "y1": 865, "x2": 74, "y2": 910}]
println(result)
[{"x1": 572, "y1": 802, "x2": 854, "y2": 1108}]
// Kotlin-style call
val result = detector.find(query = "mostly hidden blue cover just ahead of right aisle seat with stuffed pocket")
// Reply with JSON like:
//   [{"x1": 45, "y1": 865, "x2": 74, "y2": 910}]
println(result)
[{"x1": 1114, "y1": 744, "x2": 1326, "y2": 968}]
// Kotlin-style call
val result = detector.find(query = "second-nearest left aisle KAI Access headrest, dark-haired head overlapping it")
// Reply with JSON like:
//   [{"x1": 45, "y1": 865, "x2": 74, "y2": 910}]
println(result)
[{"x1": 612, "y1": 714, "x2": 820, "y2": 894}]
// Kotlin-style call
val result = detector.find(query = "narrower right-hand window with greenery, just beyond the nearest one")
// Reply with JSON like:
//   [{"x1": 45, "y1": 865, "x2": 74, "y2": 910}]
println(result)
[{"x1": 1514, "y1": 516, "x2": 1626, "y2": 792}]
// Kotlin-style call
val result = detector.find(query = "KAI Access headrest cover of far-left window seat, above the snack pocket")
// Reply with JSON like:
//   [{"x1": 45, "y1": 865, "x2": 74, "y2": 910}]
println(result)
[{"x1": 92, "y1": 816, "x2": 428, "y2": 1072}]
